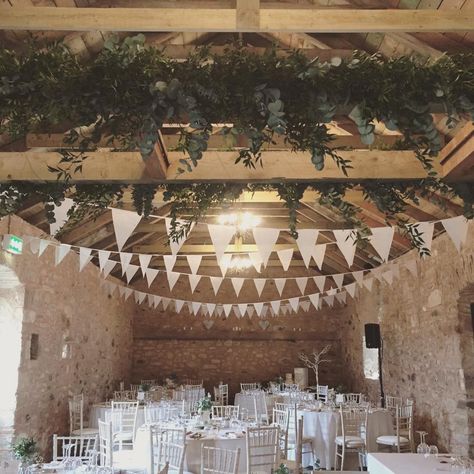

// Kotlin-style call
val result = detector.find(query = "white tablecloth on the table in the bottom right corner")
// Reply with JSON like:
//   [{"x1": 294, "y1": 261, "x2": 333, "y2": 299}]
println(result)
[{"x1": 367, "y1": 453, "x2": 460, "y2": 474}]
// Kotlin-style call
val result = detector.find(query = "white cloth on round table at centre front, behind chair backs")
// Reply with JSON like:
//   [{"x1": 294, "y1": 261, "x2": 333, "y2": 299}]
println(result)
[{"x1": 134, "y1": 427, "x2": 247, "y2": 474}]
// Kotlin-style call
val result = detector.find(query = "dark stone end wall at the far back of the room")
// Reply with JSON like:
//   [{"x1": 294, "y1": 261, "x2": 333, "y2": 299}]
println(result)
[{"x1": 132, "y1": 267, "x2": 350, "y2": 400}]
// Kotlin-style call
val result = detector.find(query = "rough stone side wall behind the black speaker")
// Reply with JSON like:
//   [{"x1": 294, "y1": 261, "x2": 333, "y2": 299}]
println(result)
[{"x1": 342, "y1": 223, "x2": 474, "y2": 454}]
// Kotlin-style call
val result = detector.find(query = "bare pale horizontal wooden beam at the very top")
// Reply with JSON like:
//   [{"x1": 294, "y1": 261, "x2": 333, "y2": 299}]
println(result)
[{"x1": 0, "y1": 6, "x2": 474, "y2": 33}]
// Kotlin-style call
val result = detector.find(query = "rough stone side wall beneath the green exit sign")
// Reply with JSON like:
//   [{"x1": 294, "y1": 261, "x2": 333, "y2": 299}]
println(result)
[{"x1": 0, "y1": 217, "x2": 135, "y2": 470}]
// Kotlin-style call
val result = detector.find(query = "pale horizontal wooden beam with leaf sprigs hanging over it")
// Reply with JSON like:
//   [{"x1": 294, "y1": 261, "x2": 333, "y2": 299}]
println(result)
[{"x1": 0, "y1": 150, "x2": 442, "y2": 184}]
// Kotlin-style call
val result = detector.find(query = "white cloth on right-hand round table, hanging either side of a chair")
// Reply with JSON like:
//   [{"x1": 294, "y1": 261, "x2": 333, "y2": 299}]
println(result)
[{"x1": 299, "y1": 410, "x2": 393, "y2": 469}]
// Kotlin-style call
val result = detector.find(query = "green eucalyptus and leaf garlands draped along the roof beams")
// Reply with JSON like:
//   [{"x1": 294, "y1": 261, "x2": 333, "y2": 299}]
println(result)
[{"x1": 0, "y1": 35, "x2": 474, "y2": 252}]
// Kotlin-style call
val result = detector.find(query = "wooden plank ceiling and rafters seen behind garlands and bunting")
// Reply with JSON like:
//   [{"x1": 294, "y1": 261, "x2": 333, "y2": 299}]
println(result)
[{"x1": 0, "y1": 0, "x2": 474, "y2": 288}]
